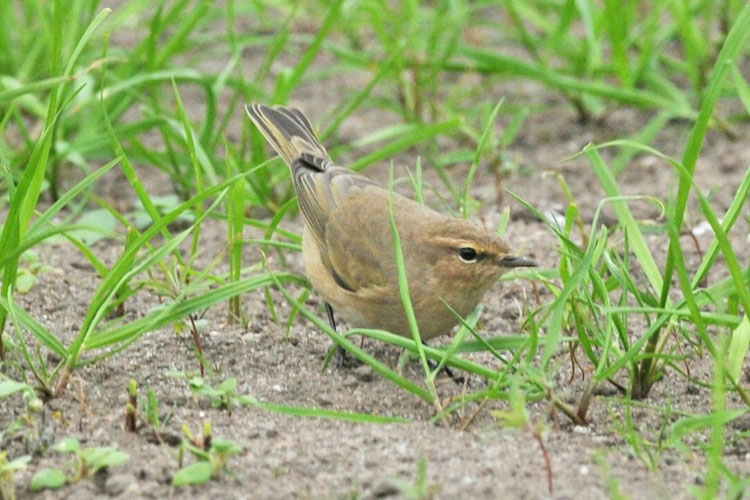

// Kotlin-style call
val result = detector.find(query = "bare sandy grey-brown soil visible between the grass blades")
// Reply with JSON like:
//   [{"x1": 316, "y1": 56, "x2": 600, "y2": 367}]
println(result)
[{"x1": 0, "y1": 4, "x2": 750, "y2": 500}]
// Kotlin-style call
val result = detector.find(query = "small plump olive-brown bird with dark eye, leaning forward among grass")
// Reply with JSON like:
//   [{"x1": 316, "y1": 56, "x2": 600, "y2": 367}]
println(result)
[{"x1": 250, "y1": 104, "x2": 536, "y2": 340}]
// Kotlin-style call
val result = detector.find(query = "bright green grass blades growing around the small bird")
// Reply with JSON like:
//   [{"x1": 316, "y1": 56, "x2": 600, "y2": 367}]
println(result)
[{"x1": 0, "y1": 0, "x2": 750, "y2": 498}]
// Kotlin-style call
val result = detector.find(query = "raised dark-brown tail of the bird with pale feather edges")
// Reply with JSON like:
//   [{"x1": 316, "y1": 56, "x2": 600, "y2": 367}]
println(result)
[{"x1": 245, "y1": 104, "x2": 332, "y2": 171}]
